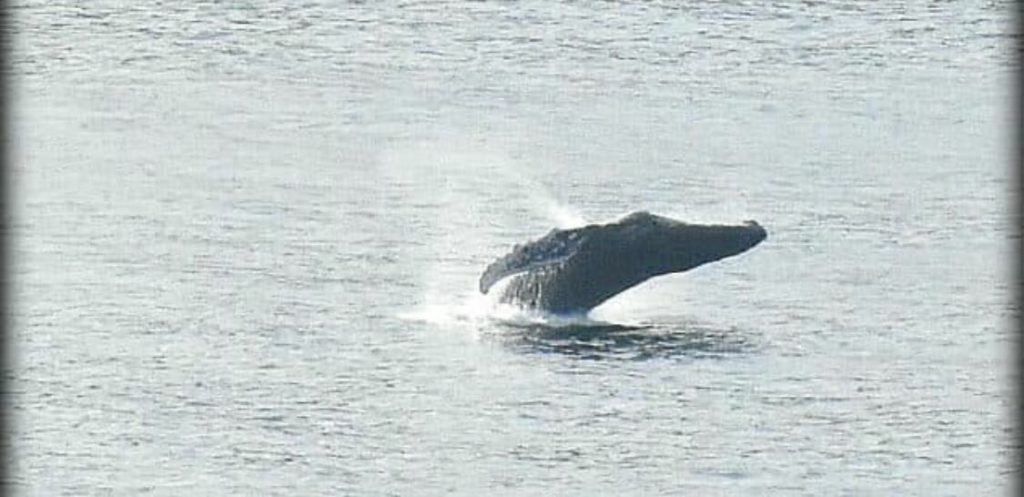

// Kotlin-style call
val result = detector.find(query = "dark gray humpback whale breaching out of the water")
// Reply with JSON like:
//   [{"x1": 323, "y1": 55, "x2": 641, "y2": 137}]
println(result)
[{"x1": 480, "y1": 211, "x2": 768, "y2": 315}]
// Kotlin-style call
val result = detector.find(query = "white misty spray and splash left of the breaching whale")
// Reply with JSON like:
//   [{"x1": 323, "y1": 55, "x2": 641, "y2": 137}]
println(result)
[{"x1": 378, "y1": 135, "x2": 590, "y2": 327}]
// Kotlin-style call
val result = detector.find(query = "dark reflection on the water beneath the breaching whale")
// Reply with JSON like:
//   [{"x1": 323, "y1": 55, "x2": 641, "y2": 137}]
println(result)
[{"x1": 495, "y1": 323, "x2": 755, "y2": 361}]
